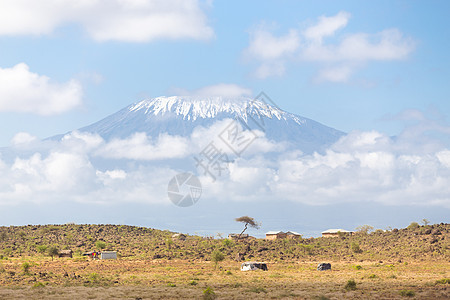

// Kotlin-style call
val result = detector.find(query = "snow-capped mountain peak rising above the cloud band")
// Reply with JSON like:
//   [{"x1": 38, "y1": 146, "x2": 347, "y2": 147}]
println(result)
[{"x1": 79, "y1": 96, "x2": 344, "y2": 153}]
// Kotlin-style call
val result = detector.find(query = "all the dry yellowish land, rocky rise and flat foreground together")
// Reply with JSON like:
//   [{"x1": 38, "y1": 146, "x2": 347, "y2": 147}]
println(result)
[{"x1": 0, "y1": 224, "x2": 450, "y2": 300}]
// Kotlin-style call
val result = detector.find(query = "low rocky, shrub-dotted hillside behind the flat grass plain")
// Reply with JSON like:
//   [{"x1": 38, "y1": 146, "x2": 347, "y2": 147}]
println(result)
[{"x1": 0, "y1": 223, "x2": 450, "y2": 262}]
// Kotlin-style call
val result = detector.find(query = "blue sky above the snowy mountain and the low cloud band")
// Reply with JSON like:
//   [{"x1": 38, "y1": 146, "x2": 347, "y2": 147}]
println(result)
[{"x1": 0, "y1": 1, "x2": 450, "y2": 146}]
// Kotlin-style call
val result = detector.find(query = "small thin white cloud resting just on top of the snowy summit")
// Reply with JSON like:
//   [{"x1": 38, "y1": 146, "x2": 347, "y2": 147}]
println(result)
[{"x1": 171, "y1": 83, "x2": 252, "y2": 97}]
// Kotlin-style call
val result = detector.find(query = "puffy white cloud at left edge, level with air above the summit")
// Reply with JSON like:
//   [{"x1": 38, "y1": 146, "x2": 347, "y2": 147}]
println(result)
[{"x1": 0, "y1": 63, "x2": 83, "y2": 115}]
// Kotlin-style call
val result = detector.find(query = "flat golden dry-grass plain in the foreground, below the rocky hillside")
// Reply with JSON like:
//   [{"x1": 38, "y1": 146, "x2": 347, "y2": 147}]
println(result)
[{"x1": 0, "y1": 257, "x2": 450, "y2": 299}]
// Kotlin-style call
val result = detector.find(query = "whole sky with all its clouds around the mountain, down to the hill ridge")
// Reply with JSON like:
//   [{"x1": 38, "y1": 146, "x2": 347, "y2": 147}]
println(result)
[{"x1": 0, "y1": 0, "x2": 450, "y2": 235}]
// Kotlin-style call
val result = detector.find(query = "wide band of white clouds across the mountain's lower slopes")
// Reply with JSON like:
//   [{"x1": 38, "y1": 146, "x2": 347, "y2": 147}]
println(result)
[{"x1": 0, "y1": 114, "x2": 450, "y2": 208}]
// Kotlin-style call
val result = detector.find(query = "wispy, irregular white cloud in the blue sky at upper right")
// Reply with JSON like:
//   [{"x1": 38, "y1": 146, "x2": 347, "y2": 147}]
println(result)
[{"x1": 244, "y1": 12, "x2": 415, "y2": 82}]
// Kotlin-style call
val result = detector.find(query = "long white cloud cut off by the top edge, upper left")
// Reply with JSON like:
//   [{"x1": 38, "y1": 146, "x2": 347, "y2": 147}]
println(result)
[{"x1": 0, "y1": 0, "x2": 214, "y2": 42}]
